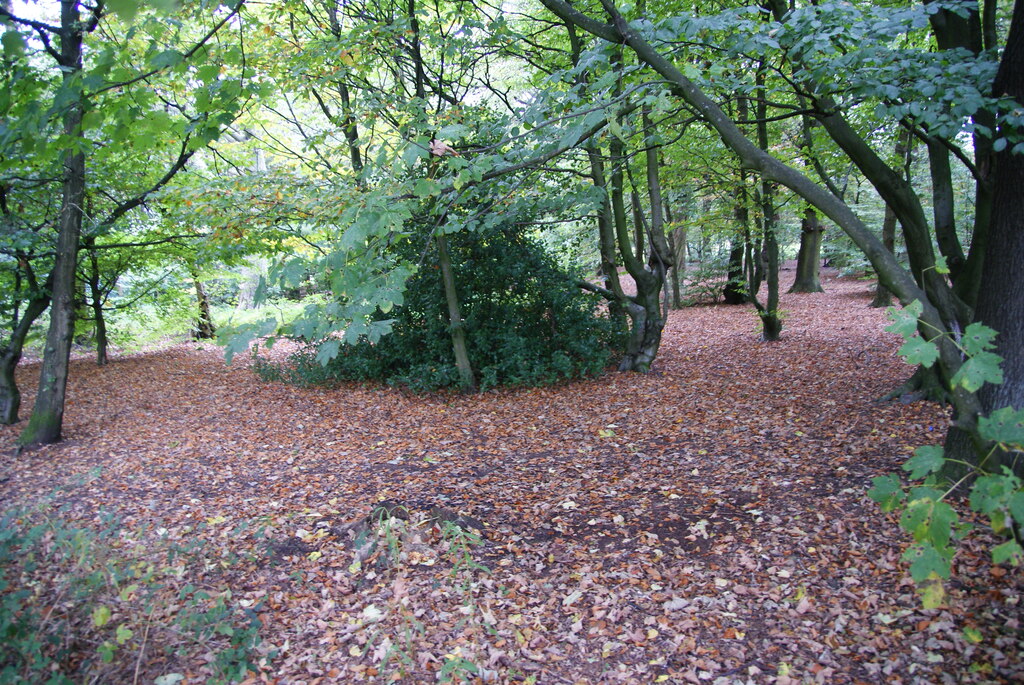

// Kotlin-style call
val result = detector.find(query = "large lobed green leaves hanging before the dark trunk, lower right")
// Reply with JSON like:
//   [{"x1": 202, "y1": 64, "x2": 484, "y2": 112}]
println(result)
[{"x1": 868, "y1": 301, "x2": 1024, "y2": 608}]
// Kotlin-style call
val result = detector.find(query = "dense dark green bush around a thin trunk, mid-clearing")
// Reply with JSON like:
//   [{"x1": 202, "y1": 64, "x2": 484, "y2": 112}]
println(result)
[{"x1": 257, "y1": 223, "x2": 613, "y2": 391}]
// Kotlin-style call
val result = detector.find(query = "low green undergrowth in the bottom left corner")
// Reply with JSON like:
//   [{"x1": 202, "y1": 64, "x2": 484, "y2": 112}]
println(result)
[{"x1": 0, "y1": 483, "x2": 268, "y2": 683}]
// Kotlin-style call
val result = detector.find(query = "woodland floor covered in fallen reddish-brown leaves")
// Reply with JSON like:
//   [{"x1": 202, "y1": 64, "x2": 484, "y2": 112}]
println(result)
[{"x1": 0, "y1": 271, "x2": 1024, "y2": 685}]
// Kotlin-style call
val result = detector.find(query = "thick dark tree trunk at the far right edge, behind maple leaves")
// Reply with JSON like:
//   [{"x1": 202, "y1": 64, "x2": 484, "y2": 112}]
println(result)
[{"x1": 944, "y1": 0, "x2": 1024, "y2": 477}]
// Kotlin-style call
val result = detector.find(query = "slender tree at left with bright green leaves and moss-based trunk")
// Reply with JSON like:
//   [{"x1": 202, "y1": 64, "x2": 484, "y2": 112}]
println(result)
[{"x1": 0, "y1": 0, "x2": 253, "y2": 445}]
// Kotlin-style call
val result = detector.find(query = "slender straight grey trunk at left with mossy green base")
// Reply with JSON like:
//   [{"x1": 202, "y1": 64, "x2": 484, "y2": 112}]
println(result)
[{"x1": 18, "y1": 0, "x2": 85, "y2": 445}]
